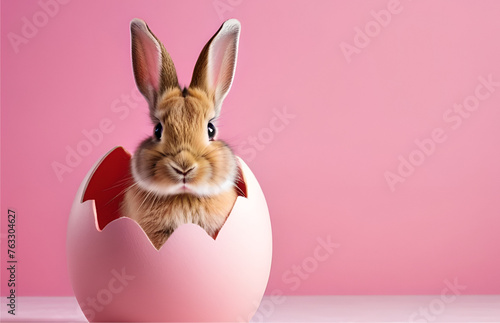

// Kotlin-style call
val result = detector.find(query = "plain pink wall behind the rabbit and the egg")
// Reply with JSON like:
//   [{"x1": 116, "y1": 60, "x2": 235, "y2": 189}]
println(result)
[{"x1": 1, "y1": 0, "x2": 500, "y2": 295}]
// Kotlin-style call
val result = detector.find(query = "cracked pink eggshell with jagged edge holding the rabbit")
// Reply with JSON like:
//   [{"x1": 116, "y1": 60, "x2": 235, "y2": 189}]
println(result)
[{"x1": 66, "y1": 147, "x2": 272, "y2": 322}]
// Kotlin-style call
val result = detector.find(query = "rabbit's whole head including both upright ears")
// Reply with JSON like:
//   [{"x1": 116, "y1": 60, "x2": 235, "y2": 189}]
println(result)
[{"x1": 131, "y1": 19, "x2": 240, "y2": 197}]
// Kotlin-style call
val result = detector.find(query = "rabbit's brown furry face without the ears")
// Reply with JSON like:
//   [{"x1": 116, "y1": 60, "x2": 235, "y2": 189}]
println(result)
[{"x1": 132, "y1": 88, "x2": 237, "y2": 197}]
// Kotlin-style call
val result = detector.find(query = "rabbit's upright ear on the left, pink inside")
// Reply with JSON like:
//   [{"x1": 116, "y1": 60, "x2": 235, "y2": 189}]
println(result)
[{"x1": 130, "y1": 18, "x2": 179, "y2": 109}]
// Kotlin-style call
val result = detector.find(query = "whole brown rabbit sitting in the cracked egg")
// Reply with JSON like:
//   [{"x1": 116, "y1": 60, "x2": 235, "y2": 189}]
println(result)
[{"x1": 120, "y1": 19, "x2": 241, "y2": 249}]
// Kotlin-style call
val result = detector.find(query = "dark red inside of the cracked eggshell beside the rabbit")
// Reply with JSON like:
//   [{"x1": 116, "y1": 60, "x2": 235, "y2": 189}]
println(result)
[{"x1": 82, "y1": 147, "x2": 247, "y2": 231}]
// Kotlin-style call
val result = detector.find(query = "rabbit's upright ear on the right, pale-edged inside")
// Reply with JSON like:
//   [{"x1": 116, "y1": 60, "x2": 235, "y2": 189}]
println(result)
[{"x1": 190, "y1": 19, "x2": 241, "y2": 113}]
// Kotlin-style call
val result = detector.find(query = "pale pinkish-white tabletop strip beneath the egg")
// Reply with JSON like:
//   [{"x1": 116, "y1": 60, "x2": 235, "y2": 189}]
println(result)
[{"x1": 1, "y1": 295, "x2": 500, "y2": 322}]
